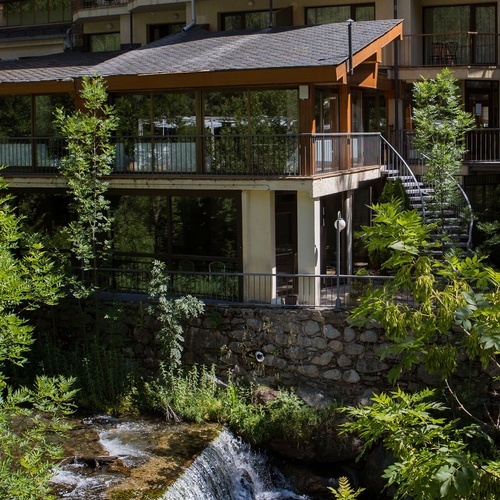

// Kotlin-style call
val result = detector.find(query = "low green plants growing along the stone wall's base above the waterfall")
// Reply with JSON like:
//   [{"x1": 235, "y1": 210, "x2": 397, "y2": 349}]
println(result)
[{"x1": 146, "y1": 366, "x2": 338, "y2": 445}]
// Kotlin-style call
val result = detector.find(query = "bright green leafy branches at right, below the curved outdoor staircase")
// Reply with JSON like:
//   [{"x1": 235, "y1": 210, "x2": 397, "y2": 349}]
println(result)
[{"x1": 351, "y1": 204, "x2": 500, "y2": 382}]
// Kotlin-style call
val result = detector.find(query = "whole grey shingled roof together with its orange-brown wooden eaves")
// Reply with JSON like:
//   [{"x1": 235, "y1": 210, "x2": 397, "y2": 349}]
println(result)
[{"x1": 0, "y1": 20, "x2": 402, "y2": 94}]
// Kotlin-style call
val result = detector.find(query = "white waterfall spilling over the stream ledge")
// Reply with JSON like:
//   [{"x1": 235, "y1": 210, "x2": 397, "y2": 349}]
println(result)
[{"x1": 163, "y1": 431, "x2": 308, "y2": 500}]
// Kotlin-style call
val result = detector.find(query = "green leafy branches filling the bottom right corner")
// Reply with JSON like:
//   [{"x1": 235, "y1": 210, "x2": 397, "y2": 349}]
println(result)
[{"x1": 342, "y1": 389, "x2": 500, "y2": 500}]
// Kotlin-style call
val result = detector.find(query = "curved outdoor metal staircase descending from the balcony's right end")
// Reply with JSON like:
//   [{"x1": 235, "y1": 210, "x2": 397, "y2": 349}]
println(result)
[{"x1": 382, "y1": 137, "x2": 474, "y2": 255}]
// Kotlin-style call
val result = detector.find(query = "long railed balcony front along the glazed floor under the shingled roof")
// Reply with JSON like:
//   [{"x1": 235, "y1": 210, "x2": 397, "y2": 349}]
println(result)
[{"x1": 0, "y1": 133, "x2": 382, "y2": 177}]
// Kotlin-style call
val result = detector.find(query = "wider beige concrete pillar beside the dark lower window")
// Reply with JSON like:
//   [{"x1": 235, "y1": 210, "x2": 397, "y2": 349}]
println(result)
[{"x1": 241, "y1": 191, "x2": 276, "y2": 303}]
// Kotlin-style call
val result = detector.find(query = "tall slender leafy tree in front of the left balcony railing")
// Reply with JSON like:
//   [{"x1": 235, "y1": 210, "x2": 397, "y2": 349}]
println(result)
[{"x1": 55, "y1": 75, "x2": 118, "y2": 269}]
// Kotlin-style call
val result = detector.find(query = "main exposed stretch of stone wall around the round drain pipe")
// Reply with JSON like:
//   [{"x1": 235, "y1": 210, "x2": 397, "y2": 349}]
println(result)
[{"x1": 184, "y1": 307, "x2": 402, "y2": 401}]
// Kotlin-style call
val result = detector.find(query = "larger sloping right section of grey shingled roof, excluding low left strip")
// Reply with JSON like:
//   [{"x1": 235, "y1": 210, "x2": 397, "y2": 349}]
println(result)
[{"x1": 96, "y1": 20, "x2": 401, "y2": 76}]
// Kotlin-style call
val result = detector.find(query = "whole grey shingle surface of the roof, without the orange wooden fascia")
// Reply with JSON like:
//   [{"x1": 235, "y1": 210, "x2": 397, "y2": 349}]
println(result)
[{"x1": 0, "y1": 20, "x2": 402, "y2": 85}]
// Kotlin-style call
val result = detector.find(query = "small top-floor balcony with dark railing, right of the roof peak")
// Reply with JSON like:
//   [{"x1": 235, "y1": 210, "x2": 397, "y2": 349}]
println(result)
[{"x1": 399, "y1": 32, "x2": 499, "y2": 67}]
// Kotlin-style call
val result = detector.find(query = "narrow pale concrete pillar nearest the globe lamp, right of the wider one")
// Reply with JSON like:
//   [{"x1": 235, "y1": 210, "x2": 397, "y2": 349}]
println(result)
[{"x1": 297, "y1": 191, "x2": 321, "y2": 305}]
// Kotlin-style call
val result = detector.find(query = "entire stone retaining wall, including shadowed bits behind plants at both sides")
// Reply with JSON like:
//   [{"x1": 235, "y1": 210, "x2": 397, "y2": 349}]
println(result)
[{"x1": 28, "y1": 301, "x2": 488, "y2": 403}]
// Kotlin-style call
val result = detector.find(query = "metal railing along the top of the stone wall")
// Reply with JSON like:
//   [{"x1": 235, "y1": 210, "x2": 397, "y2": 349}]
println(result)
[{"x1": 81, "y1": 268, "x2": 413, "y2": 308}]
